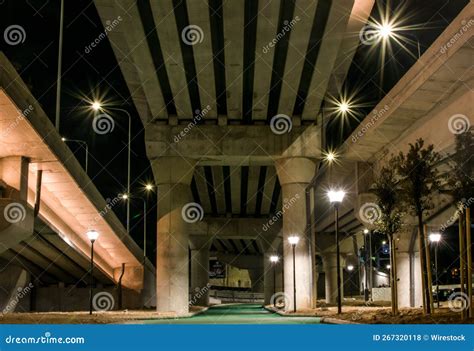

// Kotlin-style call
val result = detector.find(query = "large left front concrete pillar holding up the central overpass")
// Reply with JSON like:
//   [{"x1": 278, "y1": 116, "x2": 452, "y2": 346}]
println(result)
[{"x1": 152, "y1": 157, "x2": 195, "y2": 315}]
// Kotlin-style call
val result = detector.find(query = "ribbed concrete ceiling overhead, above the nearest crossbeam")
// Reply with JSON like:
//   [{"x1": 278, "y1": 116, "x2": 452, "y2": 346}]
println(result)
[{"x1": 95, "y1": 0, "x2": 374, "y2": 124}]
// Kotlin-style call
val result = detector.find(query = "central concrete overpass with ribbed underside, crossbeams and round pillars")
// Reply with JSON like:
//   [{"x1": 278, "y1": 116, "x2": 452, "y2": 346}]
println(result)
[{"x1": 90, "y1": 0, "x2": 472, "y2": 314}]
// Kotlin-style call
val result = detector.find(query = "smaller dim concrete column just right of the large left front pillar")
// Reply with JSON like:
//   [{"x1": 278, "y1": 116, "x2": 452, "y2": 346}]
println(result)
[{"x1": 189, "y1": 237, "x2": 211, "y2": 306}]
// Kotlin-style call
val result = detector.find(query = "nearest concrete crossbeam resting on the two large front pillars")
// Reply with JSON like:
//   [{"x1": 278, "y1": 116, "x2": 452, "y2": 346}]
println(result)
[{"x1": 145, "y1": 125, "x2": 321, "y2": 166}]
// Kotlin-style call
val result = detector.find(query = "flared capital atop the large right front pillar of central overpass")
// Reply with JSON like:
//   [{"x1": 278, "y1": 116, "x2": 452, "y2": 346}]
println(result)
[{"x1": 275, "y1": 157, "x2": 316, "y2": 186}]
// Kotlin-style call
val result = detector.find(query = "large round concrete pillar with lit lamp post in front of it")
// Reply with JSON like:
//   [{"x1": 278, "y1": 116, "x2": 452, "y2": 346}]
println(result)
[{"x1": 275, "y1": 157, "x2": 315, "y2": 311}]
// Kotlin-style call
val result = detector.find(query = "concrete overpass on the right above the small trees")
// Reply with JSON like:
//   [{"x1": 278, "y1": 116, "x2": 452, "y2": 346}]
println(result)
[{"x1": 314, "y1": 3, "x2": 474, "y2": 307}]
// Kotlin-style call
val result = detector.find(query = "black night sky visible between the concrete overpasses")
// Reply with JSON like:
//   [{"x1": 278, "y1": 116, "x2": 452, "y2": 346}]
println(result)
[{"x1": 0, "y1": 0, "x2": 468, "y2": 266}]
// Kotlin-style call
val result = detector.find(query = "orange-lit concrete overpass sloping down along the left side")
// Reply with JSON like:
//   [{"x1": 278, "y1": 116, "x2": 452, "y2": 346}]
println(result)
[{"x1": 0, "y1": 53, "x2": 154, "y2": 310}]
